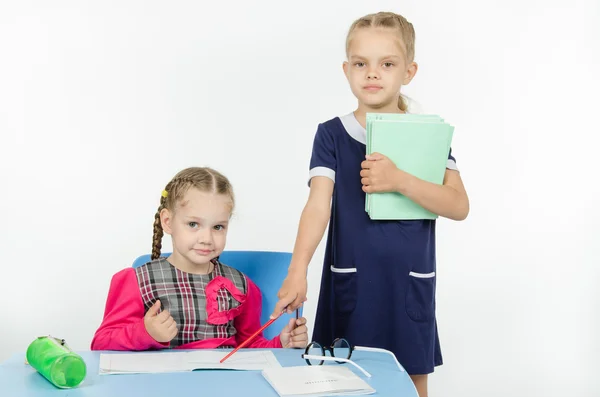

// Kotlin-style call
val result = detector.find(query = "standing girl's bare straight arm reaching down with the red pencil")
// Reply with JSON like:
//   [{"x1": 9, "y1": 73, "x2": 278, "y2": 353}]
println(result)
[{"x1": 272, "y1": 176, "x2": 334, "y2": 317}]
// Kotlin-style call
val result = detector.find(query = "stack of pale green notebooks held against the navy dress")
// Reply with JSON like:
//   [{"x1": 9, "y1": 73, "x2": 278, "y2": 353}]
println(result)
[{"x1": 365, "y1": 113, "x2": 454, "y2": 220}]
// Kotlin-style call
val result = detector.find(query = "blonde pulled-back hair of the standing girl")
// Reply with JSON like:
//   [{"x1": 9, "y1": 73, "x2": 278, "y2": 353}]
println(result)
[{"x1": 346, "y1": 11, "x2": 415, "y2": 111}]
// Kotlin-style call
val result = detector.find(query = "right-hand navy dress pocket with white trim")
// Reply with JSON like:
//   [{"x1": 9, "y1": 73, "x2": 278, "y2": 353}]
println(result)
[{"x1": 406, "y1": 272, "x2": 435, "y2": 322}]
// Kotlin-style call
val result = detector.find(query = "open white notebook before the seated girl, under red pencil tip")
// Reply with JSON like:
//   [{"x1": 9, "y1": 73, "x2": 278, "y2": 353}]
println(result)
[{"x1": 99, "y1": 349, "x2": 281, "y2": 375}]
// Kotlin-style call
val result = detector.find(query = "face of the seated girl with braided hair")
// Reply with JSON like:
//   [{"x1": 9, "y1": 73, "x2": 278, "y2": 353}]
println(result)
[{"x1": 161, "y1": 188, "x2": 231, "y2": 270}]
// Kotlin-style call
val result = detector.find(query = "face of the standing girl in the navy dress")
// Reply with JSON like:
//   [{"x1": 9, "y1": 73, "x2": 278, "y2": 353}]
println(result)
[{"x1": 343, "y1": 28, "x2": 417, "y2": 112}]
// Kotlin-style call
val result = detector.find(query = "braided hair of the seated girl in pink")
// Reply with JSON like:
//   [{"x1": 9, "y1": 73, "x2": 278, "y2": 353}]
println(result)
[{"x1": 152, "y1": 167, "x2": 235, "y2": 260}]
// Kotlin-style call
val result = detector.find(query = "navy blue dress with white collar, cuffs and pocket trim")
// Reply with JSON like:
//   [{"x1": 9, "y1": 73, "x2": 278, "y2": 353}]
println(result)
[{"x1": 309, "y1": 113, "x2": 456, "y2": 375}]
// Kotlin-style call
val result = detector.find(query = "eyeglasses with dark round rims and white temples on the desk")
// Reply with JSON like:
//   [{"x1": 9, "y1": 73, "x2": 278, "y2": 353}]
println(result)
[{"x1": 302, "y1": 338, "x2": 405, "y2": 378}]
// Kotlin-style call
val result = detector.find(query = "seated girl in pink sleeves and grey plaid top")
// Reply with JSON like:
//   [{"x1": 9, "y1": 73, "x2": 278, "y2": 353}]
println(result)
[{"x1": 91, "y1": 167, "x2": 308, "y2": 350}]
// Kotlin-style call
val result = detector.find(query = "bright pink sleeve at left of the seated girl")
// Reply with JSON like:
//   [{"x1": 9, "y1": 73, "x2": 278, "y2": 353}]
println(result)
[{"x1": 91, "y1": 268, "x2": 169, "y2": 350}]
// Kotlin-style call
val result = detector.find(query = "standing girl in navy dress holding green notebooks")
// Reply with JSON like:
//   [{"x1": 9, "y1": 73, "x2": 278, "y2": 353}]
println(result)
[{"x1": 273, "y1": 12, "x2": 469, "y2": 397}]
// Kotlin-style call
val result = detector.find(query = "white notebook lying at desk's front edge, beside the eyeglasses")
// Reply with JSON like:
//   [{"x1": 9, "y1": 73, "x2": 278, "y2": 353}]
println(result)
[{"x1": 262, "y1": 365, "x2": 375, "y2": 397}]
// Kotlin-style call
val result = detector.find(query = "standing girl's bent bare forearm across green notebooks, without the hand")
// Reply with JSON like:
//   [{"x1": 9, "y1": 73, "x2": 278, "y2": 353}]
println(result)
[{"x1": 396, "y1": 169, "x2": 469, "y2": 221}]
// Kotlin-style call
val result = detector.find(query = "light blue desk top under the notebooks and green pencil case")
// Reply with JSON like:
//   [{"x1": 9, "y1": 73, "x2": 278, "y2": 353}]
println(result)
[{"x1": 0, "y1": 349, "x2": 417, "y2": 397}]
